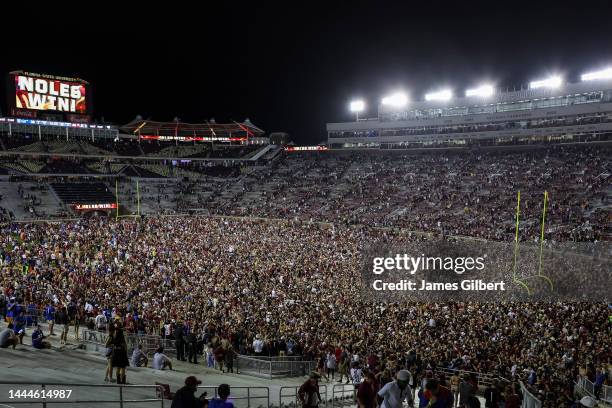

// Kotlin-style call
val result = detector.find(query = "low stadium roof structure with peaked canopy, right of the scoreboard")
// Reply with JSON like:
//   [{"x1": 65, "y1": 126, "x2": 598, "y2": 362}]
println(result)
[{"x1": 120, "y1": 118, "x2": 264, "y2": 141}]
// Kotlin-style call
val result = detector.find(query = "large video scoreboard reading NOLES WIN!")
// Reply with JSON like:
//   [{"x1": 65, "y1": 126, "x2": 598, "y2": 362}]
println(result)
[{"x1": 7, "y1": 71, "x2": 92, "y2": 123}]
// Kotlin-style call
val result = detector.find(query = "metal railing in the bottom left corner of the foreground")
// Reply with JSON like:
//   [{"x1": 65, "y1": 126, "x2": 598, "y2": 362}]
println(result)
[{"x1": 0, "y1": 381, "x2": 165, "y2": 408}]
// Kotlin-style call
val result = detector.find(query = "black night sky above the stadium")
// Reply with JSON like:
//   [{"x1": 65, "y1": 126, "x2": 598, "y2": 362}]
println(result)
[{"x1": 0, "y1": 0, "x2": 612, "y2": 144}]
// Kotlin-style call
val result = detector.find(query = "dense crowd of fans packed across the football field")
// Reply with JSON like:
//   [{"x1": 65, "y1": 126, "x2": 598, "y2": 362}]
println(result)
[{"x1": 0, "y1": 215, "x2": 612, "y2": 407}]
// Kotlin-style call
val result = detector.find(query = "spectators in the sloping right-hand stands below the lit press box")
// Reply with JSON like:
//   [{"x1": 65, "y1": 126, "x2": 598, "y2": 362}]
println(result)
[{"x1": 208, "y1": 147, "x2": 611, "y2": 242}]
